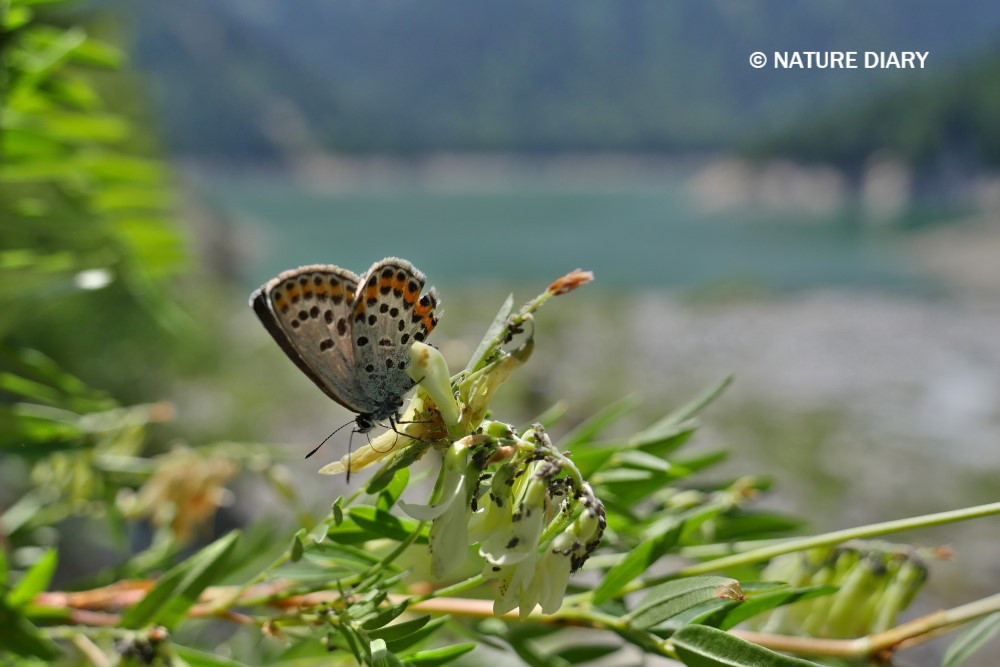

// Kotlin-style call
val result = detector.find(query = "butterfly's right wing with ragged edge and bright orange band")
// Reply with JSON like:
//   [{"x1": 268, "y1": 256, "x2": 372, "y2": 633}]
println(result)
[{"x1": 352, "y1": 257, "x2": 438, "y2": 410}]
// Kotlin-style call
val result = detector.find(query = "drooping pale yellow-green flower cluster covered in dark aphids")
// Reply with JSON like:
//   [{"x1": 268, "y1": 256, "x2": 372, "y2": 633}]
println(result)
[{"x1": 401, "y1": 422, "x2": 605, "y2": 617}]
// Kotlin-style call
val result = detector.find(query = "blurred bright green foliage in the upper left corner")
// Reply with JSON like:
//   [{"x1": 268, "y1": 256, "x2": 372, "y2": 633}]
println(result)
[{"x1": 0, "y1": 0, "x2": 185, "y2": 400}]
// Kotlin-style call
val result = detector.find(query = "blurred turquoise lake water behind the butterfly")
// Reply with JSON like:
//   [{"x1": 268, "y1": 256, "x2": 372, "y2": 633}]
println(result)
[{"x1": 199, "y1": 178, "x2": 923, "y2": 291}]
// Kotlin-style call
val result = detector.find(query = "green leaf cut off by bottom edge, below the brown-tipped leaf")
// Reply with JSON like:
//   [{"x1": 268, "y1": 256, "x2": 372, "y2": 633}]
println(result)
[{"x1": 671, "y1": 625, "x2": 819, "y2": 667}]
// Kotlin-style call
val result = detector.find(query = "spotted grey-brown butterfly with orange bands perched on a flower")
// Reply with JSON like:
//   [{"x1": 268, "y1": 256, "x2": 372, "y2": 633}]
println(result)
[{"x1": 250, "y1": 257, "x2": 438, "y2": 456}]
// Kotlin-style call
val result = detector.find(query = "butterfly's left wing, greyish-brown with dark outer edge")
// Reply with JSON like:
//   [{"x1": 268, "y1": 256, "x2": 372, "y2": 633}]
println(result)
[{"x1": 250, "y1": 264, "x2": 373, "y2": 414}]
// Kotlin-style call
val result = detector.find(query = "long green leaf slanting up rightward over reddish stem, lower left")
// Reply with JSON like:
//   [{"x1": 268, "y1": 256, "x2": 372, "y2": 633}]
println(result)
[{"x1": 121, "y1": 530, "x2": 239, "y2": 629}]
